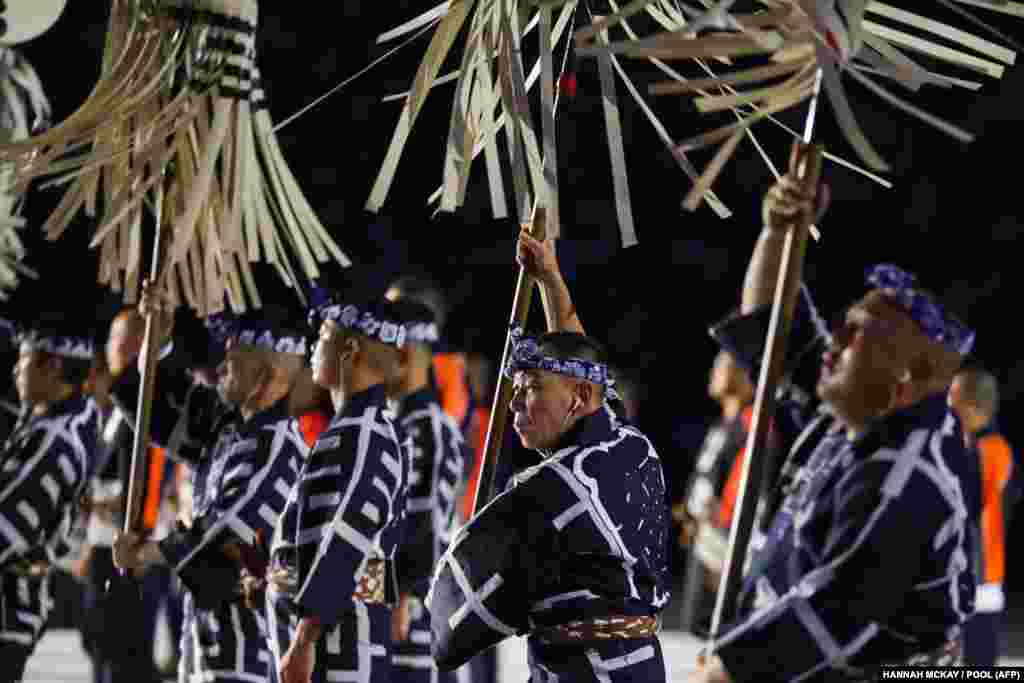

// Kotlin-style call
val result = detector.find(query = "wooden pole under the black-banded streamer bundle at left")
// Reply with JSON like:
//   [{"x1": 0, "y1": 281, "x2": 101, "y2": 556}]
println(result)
[{"x1": 124, "y1": 185, "x2": 166, "y2": 532}]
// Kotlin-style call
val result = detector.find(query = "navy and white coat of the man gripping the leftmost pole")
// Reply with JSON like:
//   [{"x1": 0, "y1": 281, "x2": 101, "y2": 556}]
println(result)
[{"x1": 115, "y1": 354, "x2": 308, "y2": 683}]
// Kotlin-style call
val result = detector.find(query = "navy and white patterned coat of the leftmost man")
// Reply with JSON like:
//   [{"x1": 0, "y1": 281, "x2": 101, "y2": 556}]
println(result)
[{"x1": 0, "y1": 395, "x2": 99, "y2": 679}]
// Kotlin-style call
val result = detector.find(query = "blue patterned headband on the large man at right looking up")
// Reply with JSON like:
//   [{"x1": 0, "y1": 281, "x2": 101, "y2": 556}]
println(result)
[{"x1": 864, "y1": 263, "x2": 975, "y2": 355}]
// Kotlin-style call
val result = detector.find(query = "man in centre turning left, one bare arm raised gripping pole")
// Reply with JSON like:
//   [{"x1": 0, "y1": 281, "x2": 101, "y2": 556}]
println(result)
[{"x1": 428, "y1": 231, "x2": 669, "y2": 683}]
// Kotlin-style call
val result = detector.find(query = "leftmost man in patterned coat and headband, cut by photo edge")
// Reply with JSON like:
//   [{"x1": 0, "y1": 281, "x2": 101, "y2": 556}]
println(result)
[{"x1": 0, "y1": 313, "x2": 99, "y2": 683}]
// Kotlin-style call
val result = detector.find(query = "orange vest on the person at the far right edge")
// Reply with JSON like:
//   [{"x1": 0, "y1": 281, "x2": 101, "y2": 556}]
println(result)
[{"x1": 977, "y1": 432, "x2": 1014, "y2": 584}]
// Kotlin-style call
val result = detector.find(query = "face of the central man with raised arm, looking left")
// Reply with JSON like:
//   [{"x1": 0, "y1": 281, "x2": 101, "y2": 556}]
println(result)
[{"x1": 509, "y1": 370, "x2": 580, "y2": 449}]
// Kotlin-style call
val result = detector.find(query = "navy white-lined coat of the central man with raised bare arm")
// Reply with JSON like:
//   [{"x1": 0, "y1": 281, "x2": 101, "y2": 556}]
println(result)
[{"x1": 428, "y1": 407, "x2": 669, "y2": 683}]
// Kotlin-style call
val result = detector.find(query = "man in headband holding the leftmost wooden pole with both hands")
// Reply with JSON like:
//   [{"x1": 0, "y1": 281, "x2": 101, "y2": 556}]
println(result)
[{"x1": 112, "y1": 291, "x2": 308, "y2": 682}]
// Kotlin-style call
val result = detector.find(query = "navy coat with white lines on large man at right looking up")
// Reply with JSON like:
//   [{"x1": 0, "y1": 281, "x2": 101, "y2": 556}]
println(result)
[{"x1": 713, "y1": 296, "x2": 974, "y2": 681}]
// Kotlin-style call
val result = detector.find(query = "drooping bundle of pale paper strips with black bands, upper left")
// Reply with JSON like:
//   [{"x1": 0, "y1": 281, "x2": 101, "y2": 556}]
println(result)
[{"x1": 0, "y1": 0, "x2": 349, "y2": 316}]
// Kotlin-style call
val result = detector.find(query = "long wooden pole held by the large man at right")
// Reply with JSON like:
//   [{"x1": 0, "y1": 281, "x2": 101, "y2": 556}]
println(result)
[{"x1": 707, "y1": 69, "x2": 824, "y2": 653}]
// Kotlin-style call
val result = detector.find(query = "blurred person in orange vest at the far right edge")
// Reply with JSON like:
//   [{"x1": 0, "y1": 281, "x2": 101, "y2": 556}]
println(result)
[{"x1": 949, "y1": 368, "x2": 1019, "y2": 667}]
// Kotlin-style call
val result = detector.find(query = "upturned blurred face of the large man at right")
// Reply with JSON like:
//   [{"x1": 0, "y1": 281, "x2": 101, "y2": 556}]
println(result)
[{"x1": 817, "y1": 298, "x2": 914, "y2": 418}]
